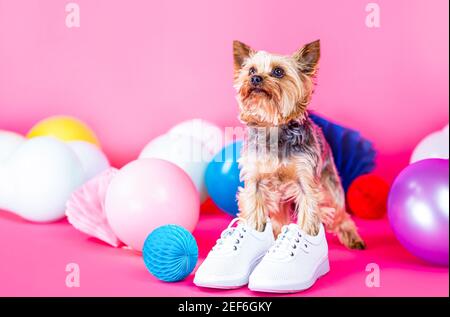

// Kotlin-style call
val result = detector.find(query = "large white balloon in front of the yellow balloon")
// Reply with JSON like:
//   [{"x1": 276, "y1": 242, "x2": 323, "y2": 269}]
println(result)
[{"x1": 0, "y1": 137, "x2": 85, "y2": 222}]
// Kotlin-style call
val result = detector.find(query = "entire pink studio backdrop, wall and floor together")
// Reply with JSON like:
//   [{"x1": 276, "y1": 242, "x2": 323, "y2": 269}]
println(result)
[{"x1": 0, "y1": 0, "x2": 449, "y2": 296}]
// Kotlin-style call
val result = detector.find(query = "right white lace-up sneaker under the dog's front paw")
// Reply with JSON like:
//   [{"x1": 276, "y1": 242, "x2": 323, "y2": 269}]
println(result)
[{"x1": 248, "y1": 224, "x2": 330, "y2": 293}]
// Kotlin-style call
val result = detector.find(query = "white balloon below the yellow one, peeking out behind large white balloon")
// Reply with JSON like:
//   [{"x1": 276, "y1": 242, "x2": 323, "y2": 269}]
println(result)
[{"x1": 67, "y1": 141, "x2": 110, "y2": 181}]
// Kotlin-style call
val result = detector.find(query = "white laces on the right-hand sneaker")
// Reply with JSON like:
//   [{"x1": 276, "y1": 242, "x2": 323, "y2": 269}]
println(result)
[{"x1": 268, "y1": 226, "x2": 308, "y2": 256}]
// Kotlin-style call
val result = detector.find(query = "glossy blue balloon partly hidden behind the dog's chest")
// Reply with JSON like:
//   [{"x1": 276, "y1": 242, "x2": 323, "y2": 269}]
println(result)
[{"x1": 205, "y1": 141, "x2": 244, "y2": 217}]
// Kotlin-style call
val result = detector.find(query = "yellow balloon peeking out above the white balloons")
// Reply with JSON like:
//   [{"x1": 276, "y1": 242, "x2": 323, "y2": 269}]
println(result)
[{"x1": 27, "y1": 116, "x2": 100, "y2": 147}]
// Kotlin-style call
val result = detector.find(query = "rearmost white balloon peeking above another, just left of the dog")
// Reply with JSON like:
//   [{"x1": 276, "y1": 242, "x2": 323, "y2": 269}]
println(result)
[{"x1": 168, "y1": 119, "x2": 224, "y2": 159}]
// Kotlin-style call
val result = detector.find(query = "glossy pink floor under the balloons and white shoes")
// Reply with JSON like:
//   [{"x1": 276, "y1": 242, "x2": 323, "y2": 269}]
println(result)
[{"x1": 0, "y1": 205, "x2": 449, "y2": 297}]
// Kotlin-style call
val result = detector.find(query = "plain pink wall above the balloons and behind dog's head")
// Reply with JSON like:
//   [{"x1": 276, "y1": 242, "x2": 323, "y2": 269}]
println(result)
[{"x1": 0, "y1": 0, "x2": 449, "y2": 178}]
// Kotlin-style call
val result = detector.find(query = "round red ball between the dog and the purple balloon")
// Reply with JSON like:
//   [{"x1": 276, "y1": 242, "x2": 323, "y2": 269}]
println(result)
[{"x1": 347, "y1": 174, "x2": 389, "y2": 219}]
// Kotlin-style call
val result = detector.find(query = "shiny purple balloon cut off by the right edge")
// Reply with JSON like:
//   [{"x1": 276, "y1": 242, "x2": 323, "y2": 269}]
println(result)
[{"x1": 388, "y1": 159, "x2": 449, "y2": 266}]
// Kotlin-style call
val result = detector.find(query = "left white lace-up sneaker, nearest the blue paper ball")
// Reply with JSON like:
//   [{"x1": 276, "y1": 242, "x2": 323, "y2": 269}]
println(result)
[{"x1": 194, "y1": 218, "x2": 275, "y2": 289}]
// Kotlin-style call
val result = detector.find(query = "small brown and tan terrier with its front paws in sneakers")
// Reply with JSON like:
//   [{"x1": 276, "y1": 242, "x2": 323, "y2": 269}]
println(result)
[{"x1": 233, "y1": 41, "x2": 365, "y2": 249}]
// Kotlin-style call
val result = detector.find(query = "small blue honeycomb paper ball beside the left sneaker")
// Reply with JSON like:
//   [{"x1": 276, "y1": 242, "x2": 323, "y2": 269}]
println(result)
[{"x1": 142, "y1": 225, "x2": 198, "y2": 282}]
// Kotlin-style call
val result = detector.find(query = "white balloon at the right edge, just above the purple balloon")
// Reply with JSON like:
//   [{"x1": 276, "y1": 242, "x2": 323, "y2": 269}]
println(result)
[{"x1": 410, "y1": 125, "x2": 449, "y2": 164}]
